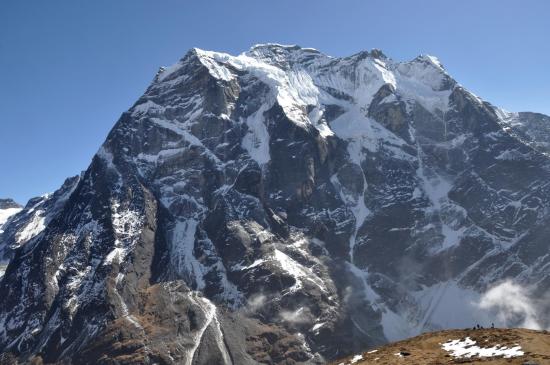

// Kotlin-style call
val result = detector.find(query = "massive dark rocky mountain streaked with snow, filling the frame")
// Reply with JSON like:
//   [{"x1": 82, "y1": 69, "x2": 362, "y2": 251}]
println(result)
[{"x1": 0, "y1": 44, "x2": 550, "y2": 364}]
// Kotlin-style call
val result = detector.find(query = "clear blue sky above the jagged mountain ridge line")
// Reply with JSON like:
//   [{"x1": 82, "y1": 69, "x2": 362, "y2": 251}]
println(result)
[{"x1": 0, "y1": 0, "x2": 550, "y2": 203}]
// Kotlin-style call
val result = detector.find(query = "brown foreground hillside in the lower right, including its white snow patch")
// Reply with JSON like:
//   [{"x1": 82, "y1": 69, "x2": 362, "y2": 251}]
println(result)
[{"x1": 334, "y1": 329, "x2": 550, "y2": 365}]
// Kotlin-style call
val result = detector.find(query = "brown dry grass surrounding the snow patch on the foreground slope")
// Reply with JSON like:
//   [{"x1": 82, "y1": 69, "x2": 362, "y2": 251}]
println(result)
[{"x1": 334, "y1": 329, "x2": 550, "y2": 365}]
